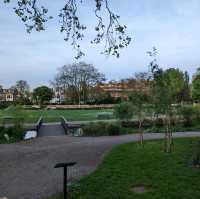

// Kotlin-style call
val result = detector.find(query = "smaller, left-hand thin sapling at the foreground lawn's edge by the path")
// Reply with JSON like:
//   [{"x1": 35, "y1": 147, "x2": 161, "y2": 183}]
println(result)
[{"x1": 129, "y1": 90, "x2": 150, "y2": 146}]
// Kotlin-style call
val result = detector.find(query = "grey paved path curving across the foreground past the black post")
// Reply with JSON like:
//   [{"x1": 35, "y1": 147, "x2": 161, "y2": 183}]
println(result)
[{"x1": 0, "y1": 132, "x2": 200, "y2": 199}]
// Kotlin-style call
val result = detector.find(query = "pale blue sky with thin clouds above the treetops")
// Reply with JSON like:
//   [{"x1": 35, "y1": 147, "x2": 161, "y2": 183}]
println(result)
[{"x1": 0, "y1": 0, "x2": 200, "y2": 88}]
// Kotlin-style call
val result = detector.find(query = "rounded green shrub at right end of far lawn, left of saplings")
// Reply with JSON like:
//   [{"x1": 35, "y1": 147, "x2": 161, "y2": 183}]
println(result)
[{"x1": 114, "y1": 102, "x2": 133, "y2": 121}]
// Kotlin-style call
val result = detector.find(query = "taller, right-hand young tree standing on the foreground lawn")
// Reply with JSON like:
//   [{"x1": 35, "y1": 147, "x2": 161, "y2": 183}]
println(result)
[{"x1": 148, "y1": 47, "x2": 176, "y2": 153}]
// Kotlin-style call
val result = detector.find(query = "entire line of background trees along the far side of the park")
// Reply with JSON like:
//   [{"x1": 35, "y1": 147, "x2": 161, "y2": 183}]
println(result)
[{"x1": 1, "y1": 58, "x2": 200, "y2": 105}]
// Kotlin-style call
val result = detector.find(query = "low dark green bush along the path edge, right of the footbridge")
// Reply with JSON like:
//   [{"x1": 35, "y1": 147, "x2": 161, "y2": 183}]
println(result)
[{"x1": 83, "y1": 122, "x2": 121, "y2": 136}]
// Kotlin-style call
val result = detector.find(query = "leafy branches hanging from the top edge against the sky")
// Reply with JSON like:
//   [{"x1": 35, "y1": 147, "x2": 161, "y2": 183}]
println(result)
[{"x1": 4, "y1": 0, "x2": 131, "y2": 59}]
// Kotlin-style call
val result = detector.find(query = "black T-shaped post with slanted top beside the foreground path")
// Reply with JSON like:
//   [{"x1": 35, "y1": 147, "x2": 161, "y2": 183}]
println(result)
[{"x1": 54, "y1": 162, "x2": 76, "y2": 199}]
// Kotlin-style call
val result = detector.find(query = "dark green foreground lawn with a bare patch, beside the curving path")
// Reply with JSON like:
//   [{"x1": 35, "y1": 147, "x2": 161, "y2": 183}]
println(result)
[{"x1": 51, "y1": 138, "x2": 200, "y2": 199}]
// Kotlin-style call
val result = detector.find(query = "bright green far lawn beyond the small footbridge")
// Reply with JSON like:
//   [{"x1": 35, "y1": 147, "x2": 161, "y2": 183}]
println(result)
[{"x1": 0, "y1": 109, "x2": 114, "y2": 123}]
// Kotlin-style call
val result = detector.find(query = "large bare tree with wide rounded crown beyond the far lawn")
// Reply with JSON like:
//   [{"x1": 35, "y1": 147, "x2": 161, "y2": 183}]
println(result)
[{"x1": 53, "y1": 62, "x2": 105, "y2": 104}]
